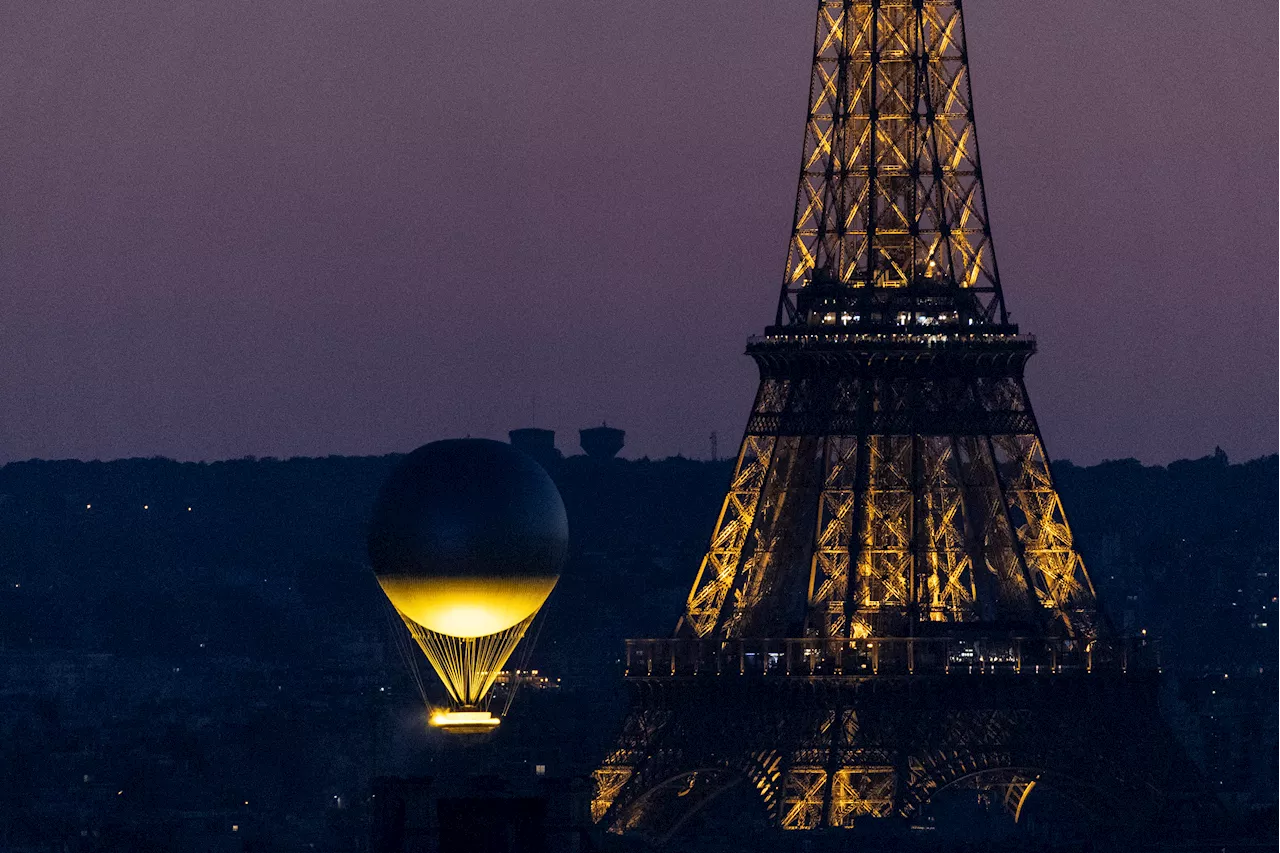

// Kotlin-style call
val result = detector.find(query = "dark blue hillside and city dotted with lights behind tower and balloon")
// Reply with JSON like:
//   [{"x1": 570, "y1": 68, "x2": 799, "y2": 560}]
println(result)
[{"x1": 0, "y1": 455, "x2": 1280, "y2": 853}]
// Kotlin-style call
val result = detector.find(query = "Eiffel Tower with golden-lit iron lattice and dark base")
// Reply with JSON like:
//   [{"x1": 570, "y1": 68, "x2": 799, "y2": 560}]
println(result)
[{"x1": 593, "y1": 0, "x2": 1201, "y2": 841}]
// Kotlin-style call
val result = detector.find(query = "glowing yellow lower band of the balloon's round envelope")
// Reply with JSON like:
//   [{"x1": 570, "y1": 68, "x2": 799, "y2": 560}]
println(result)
[{"x1": 378, "y1": 576, "x2": 557, "y2": 639}]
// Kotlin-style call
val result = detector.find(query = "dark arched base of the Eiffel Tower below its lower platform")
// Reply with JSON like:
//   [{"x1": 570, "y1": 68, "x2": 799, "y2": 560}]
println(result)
[{"x1": 595, "y1": 666, "x2": 1201, "y2": 841}]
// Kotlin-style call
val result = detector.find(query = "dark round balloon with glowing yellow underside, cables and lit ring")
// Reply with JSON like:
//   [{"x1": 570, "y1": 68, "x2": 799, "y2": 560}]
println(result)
[{"x1": 369, "y1": 438, "x2": 568, "y2": 731}]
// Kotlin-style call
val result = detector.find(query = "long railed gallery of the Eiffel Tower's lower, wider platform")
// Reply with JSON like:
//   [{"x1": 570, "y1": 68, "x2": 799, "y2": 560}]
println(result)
[{"x1": 626, "y1": 637, "x2": 1160, "y2": 679}]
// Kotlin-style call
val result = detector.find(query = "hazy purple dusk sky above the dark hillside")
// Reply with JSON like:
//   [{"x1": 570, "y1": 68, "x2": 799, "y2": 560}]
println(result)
[{"x1": 0, "y1": 0, "x2": 1280, "y2": 462}]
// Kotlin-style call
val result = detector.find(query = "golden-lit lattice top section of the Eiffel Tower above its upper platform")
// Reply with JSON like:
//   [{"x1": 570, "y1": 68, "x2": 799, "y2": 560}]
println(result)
[{"x1": 777, "y1": 0, "x2": 1006, "y2": 325}]
